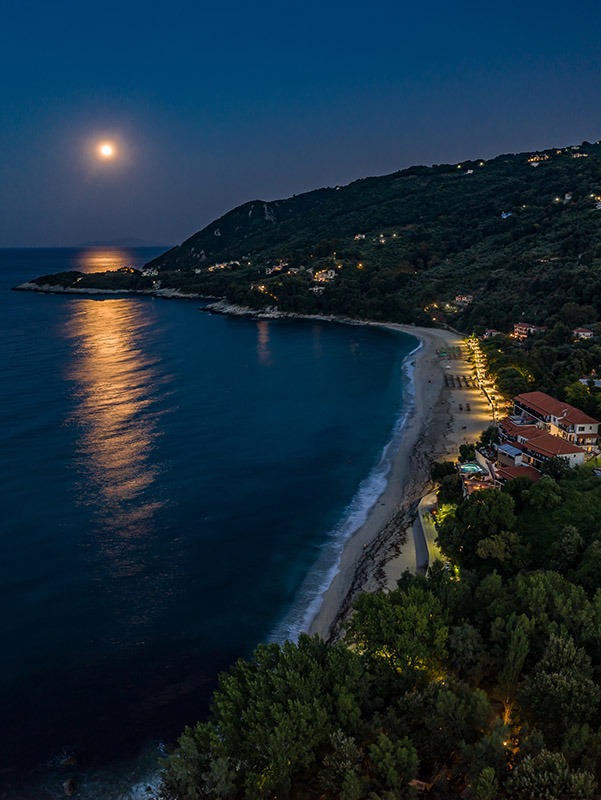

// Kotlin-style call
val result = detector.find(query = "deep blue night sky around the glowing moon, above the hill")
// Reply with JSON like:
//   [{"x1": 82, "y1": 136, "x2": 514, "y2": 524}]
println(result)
[{"x1": 0, "y1": 0, "x2": 601, "y2": 246}]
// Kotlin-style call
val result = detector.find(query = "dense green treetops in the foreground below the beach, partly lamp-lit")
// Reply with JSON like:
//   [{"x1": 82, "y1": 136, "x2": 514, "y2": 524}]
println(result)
[{"x1": 164, "y1": 464, "x2": 601, "y2": 800}]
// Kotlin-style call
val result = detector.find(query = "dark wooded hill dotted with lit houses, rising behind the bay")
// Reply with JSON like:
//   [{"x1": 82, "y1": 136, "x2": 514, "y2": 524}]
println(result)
[{"x1": 142, "y1": 142, "x2": 601, "y2": 331}]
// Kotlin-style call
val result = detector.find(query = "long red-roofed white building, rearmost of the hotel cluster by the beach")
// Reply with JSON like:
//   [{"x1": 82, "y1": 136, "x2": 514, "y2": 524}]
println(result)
[{"x1": 513, "y1": 392, "x2": 600, "y2": 447}]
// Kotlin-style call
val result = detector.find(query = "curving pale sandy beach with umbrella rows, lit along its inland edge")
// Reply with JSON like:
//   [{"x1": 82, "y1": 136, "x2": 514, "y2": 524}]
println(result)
[{"x1": 309, "y1": 323, "x2": 492, "y2": 639}]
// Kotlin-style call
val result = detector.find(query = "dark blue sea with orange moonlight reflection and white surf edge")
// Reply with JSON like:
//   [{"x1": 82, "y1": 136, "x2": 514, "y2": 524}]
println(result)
[{"x1": 0, "y1": 248, "x2": 417, "y2": 800}]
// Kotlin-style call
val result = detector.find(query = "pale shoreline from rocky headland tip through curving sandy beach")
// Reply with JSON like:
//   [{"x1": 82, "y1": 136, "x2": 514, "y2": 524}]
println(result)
[{"x1": 14, "y1": 282, "x2": 491, "y2": 640}]
